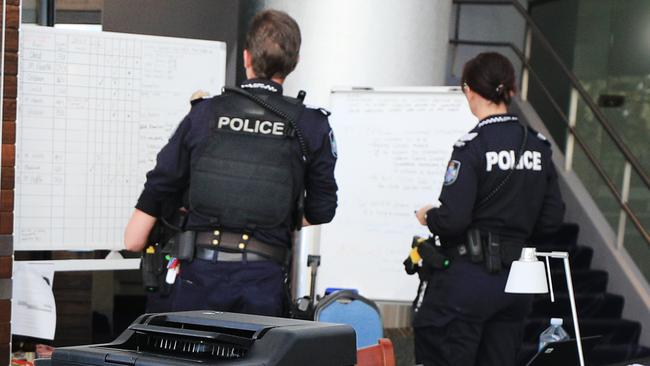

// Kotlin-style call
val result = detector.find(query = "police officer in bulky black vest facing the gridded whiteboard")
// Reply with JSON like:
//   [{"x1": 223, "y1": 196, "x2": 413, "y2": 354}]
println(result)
[{"x1": 125, "y1": 10, "x2": 337, "y2": 316}]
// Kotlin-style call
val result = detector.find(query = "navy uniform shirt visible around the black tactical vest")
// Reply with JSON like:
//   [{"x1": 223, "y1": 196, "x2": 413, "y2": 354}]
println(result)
[{"x1": 136, "y1": 79, "x2": 337, "y2": 246}]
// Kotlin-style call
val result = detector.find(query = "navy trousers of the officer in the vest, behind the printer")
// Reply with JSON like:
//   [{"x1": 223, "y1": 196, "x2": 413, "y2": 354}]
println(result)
[{"x1": 170, "y1": 258, "x2": 285, "y2": 316}]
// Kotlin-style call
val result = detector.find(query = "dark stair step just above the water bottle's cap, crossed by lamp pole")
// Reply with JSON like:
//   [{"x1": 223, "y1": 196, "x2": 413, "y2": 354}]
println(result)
[{"x1": 530, "y1": 292, "x2": 625, "y2": 319}]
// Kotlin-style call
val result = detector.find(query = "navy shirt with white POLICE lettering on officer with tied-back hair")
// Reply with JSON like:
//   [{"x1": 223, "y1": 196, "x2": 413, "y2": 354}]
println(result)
[{"x1": 426, "y1": 114, "x2": 564, "y2": 244}]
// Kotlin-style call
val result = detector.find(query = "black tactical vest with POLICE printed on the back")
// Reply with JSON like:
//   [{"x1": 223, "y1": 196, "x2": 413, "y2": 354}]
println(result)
[{"x1": 189, "y1": 90, "x2": 305, "y2": 231}]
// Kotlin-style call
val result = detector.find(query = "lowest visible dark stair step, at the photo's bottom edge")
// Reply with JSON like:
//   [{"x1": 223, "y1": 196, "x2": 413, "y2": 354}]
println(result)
[{"x1": 517, "y1": 342, "x2": 650, "y2": 366}]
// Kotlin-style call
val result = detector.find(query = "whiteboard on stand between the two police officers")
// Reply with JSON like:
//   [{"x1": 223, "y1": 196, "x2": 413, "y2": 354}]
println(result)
[{"x1": 317, "y1": 87, "x2": 478, "y2": 301}]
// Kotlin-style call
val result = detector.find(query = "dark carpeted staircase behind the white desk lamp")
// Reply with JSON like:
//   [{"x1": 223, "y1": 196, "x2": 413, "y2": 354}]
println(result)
[{"x1": 518, "y1": 224, "x2": 650, "y2": 366}]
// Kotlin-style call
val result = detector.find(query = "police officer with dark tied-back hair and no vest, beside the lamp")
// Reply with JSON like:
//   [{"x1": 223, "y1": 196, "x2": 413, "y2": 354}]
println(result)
[{"x1": 413, "y1": 53, "x2": 564, "y2": 366}]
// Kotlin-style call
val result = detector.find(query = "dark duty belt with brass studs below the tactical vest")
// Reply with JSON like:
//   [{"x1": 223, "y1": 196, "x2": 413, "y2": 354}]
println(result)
[{"x1": 195, "y1": 230, "x2": 288, "y2": 264}]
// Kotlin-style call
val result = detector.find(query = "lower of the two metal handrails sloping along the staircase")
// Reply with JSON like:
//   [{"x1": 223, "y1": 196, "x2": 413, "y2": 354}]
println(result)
[{"x1": 449, "y1": 39, "x2": 650, "y2": 244}]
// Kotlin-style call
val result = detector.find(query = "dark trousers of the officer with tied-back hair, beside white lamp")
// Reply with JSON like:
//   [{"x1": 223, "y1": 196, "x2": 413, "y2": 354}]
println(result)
[{"x1": 413, "y1": 258, "x2": 532, "y2": 366}]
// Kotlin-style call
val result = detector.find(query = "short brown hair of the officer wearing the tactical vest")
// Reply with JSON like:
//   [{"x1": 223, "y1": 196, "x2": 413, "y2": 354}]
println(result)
[{"x1": 246, "y1": 10, "x2": 301, "y2": 79}]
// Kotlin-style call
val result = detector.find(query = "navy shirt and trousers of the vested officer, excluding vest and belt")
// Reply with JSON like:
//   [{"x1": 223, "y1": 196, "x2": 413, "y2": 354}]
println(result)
[{"x1": 136, "y1": 79, "x2": 337, "y2": 315}]
